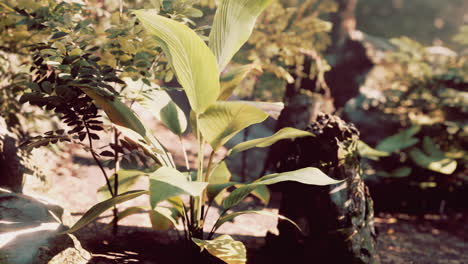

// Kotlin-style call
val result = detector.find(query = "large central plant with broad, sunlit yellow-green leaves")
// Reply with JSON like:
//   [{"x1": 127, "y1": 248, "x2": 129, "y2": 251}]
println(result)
[{"x1": 63, "y1": 0, "x2": 337, "y2": 263}]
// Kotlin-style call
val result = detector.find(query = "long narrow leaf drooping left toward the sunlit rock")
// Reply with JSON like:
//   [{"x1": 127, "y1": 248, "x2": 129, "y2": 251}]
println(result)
[{"x1": 65, "y1": 190, "x2": 148, "y2": 233}]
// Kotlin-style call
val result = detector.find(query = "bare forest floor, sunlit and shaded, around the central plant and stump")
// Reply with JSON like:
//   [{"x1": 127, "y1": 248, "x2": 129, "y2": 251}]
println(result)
[{"x1": 25, "y1": 122, "x2": 468, "y2": 264}]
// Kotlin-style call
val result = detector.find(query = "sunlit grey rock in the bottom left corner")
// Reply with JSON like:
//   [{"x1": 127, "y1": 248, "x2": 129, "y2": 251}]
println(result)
[{"x1": 0, "y1": 189, "x2": 91, "y2": 264}]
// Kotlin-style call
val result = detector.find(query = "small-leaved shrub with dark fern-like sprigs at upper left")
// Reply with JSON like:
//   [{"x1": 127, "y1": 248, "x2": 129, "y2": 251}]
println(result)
[{"x1": 0, "y1": 0, "x2": 204, "y2": 231}]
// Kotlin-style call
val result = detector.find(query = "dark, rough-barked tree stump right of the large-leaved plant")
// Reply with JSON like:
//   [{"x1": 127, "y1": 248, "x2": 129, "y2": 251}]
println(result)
[{"x1": 267, "y1": 110, "x2": 379, "y2": 264}]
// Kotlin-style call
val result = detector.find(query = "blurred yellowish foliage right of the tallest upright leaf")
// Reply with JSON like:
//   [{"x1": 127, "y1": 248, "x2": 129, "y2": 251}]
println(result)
[{"x1": 200, "y1": 0, "x2": 337, "y2": 101}]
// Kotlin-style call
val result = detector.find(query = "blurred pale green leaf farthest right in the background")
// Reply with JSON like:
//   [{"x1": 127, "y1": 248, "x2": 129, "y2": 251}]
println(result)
[{"x1": 409, "y1": 148, "x2": 457, "y2": 175}]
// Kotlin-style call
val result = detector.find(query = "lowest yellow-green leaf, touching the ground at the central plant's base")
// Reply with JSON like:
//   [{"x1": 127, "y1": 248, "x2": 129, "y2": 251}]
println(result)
[{"x1": 192, "y1": 235, "x2": 247, "y2": 264}]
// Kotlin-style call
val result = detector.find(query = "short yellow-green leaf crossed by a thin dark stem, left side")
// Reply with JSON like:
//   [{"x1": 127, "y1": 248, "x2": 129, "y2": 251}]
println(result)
[{"x1": 98, "y1": 170, "x2": 147, "y2": 200}]
